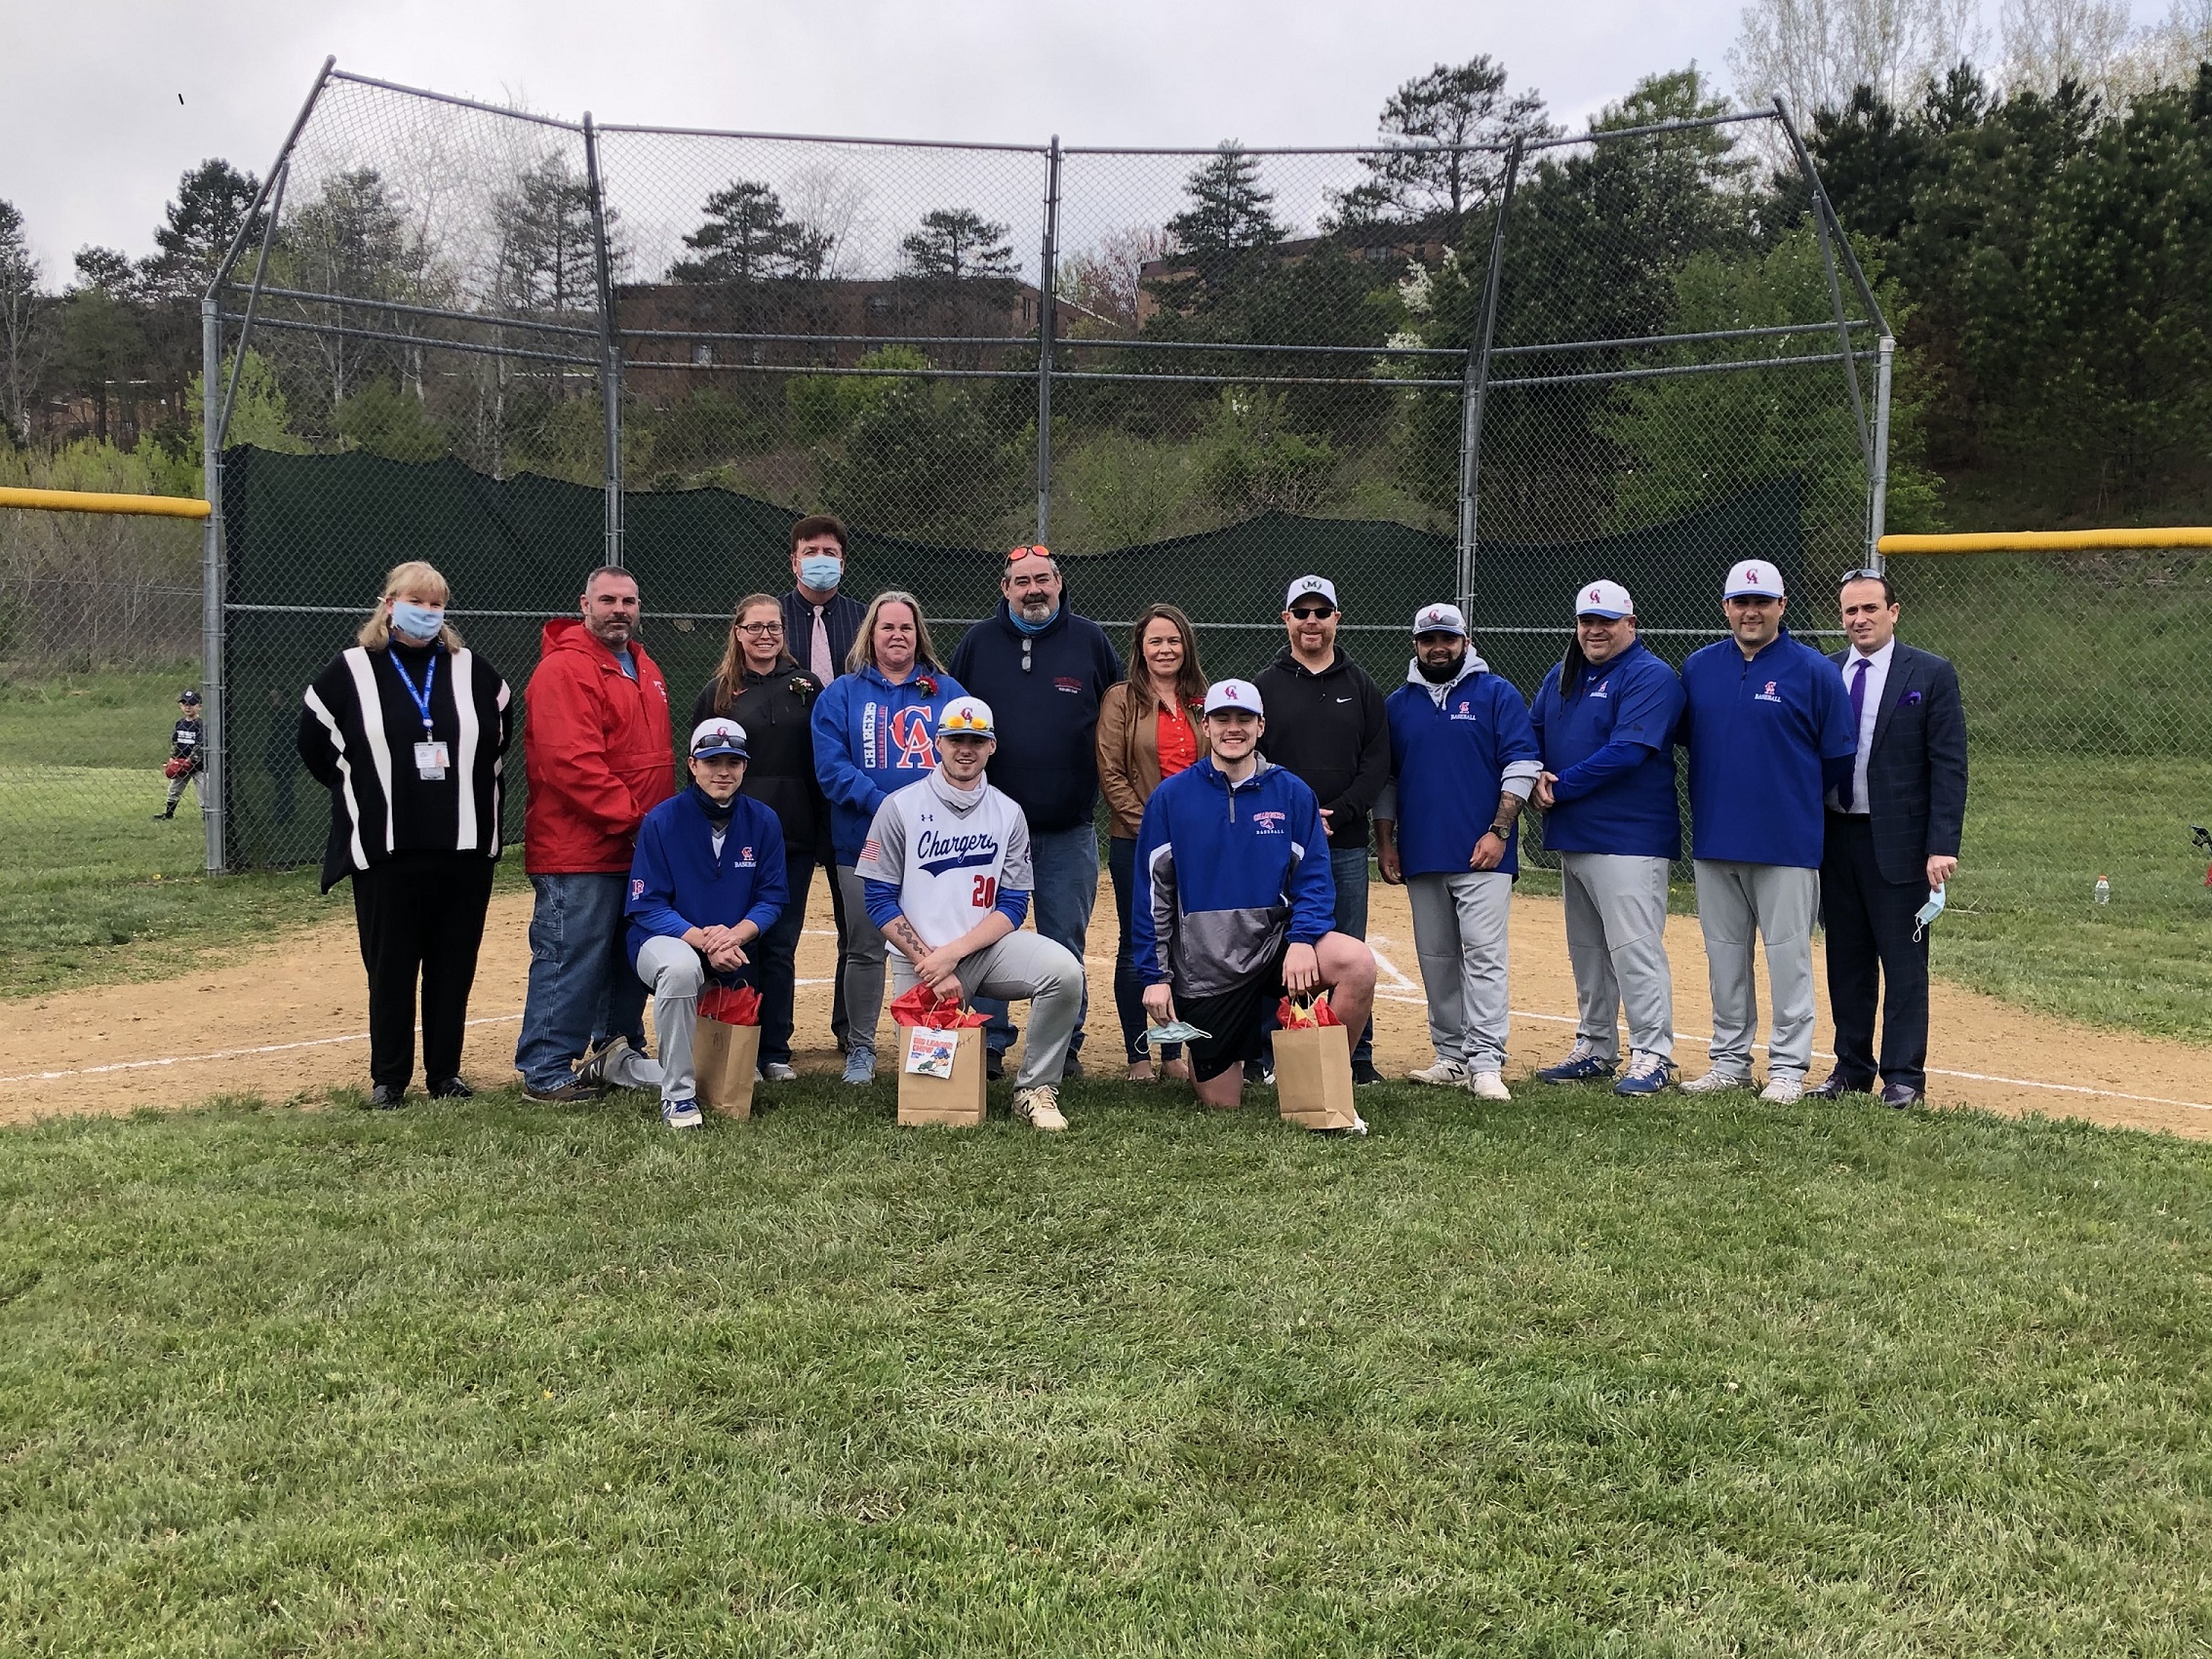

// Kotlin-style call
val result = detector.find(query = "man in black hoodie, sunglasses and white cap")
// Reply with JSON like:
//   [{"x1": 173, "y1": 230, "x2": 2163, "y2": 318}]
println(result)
[{"x1": 1254, "y1": 575, "x2": 1389, "y2": 1084}]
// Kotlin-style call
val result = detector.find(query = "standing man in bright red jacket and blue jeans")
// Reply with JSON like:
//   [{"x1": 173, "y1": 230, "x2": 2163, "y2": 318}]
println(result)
[{"x1": 515, "y1": 567, "x2": 677, "y2": 1099}]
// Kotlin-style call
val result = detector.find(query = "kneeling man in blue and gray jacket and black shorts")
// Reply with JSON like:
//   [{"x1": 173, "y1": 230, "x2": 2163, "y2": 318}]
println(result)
[{"x1": 1130, "y1": 679, "x2": 1376, "y2": 1108}]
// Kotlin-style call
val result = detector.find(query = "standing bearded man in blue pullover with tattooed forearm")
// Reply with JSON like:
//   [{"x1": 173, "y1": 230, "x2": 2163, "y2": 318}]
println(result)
[{"x1": 1376, "y1": 604, "x2": 1544, "y2": 1099}]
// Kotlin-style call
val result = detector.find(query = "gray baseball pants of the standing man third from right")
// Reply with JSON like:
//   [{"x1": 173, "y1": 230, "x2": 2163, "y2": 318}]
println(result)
[{"x1": 1560, "y1": 851, "x2": 1675, "y2": 1064}]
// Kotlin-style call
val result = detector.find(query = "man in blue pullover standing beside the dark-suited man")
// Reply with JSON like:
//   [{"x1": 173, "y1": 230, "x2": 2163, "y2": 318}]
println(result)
[{"x1": 1679, "y1": 560, "x2": 1858, "y2": 1106}]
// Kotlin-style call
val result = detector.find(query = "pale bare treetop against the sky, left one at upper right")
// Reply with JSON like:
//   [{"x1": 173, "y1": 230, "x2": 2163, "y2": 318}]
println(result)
[{"x1": 1727, "y1": 0, "x2": 1999, "y2": 122}]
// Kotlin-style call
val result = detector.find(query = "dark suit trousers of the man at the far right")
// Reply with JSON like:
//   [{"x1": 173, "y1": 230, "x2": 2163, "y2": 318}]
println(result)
[{"x1": 1821, "y1": 811, "x2": 1929, "y2": 1092}]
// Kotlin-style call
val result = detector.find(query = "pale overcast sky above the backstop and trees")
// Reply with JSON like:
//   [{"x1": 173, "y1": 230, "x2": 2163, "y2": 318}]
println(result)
[{"x1": 0, "y1": 0, "x2": 2154, "y2": 276}]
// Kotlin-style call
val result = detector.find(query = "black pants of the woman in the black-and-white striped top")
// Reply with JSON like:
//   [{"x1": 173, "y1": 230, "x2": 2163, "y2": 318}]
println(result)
[{"x1": 354, "y1": 851, "x2": 494, "y2": 1088}]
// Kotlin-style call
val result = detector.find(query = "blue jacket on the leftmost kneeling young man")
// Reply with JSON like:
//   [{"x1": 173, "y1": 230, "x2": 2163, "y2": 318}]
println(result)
[{"x1": 624, "y1": 785, "x2": 792, "y2": 967}]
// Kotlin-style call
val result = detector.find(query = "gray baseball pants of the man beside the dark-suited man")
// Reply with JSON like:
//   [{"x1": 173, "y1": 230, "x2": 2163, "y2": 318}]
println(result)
[{"x1": 1694, "y1": 858, "x2": 1821, "y2": 1082}]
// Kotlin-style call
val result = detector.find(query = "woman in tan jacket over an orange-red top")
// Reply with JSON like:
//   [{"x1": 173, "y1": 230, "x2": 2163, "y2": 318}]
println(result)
[{"x1": 1099, "y1": 604, "x2": 1205, "y2": 1084}]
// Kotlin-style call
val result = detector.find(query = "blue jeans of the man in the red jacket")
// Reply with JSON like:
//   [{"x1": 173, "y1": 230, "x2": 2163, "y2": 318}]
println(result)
[{"x1": 515, "y1": 869, "x2": 646, "y2": 1095}]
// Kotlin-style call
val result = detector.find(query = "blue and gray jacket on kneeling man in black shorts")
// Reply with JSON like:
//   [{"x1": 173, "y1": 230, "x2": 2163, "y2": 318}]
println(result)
[{"x1": 1128, "y1": 757, "x2": 1336, "y2": 998}]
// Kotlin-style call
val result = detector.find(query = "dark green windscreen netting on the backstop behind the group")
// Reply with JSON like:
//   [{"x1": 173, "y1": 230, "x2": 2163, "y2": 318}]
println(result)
[{"x1": 223, "y1": 449, "x2": 1796, "y2": 869}]
